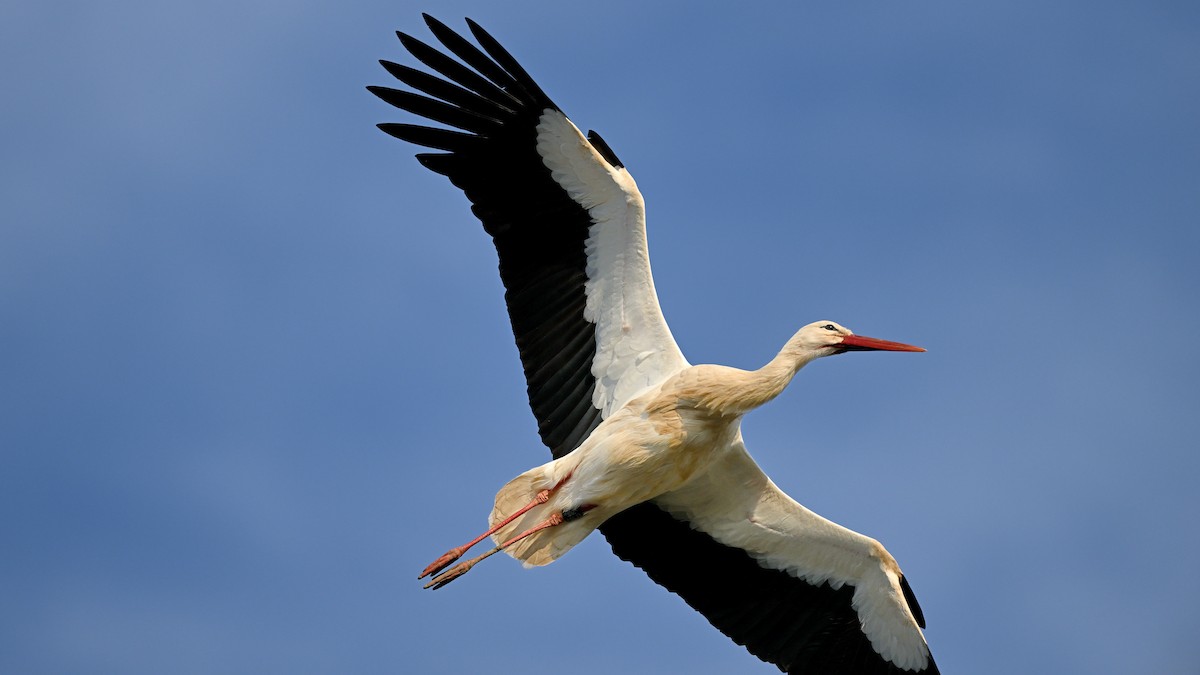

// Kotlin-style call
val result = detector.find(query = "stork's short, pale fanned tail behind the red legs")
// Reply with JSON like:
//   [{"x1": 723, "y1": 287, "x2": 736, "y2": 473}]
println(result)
[{"x1": 488, "y1": 462, "x2": 604, "y2": 567}]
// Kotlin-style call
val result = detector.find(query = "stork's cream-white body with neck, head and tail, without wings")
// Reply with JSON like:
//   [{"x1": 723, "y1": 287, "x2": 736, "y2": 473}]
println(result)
[{"x1": 490, "y1": 321, "x2": 883, "y2": 566}]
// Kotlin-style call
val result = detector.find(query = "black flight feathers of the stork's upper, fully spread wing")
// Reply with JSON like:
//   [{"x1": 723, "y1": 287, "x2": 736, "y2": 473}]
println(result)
[{"x1": 368, "y1": 17, "x2": 600, "y2": 456}]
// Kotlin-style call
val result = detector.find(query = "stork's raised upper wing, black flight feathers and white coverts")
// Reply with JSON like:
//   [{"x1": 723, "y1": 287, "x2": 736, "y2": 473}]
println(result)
[{"x1": 368, "y1": 16, "x2": 688, "y2": 458}]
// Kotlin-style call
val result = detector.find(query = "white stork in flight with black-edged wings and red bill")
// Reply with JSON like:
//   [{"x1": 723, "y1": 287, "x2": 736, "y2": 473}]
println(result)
[{"x1": 368, "y1": 16, "x2": 937, "y2": 675}]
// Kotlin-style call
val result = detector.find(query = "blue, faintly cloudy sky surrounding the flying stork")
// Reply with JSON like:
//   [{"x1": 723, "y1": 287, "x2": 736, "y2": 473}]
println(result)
[{"x1": 0, "y1": 0, "x2": 1200, "y2": 675}]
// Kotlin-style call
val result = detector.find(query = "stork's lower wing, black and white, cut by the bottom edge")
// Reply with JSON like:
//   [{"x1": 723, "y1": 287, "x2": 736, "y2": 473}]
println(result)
[{"x1": 624, "y1": 442, "x2": 938, "y2": 675}]
